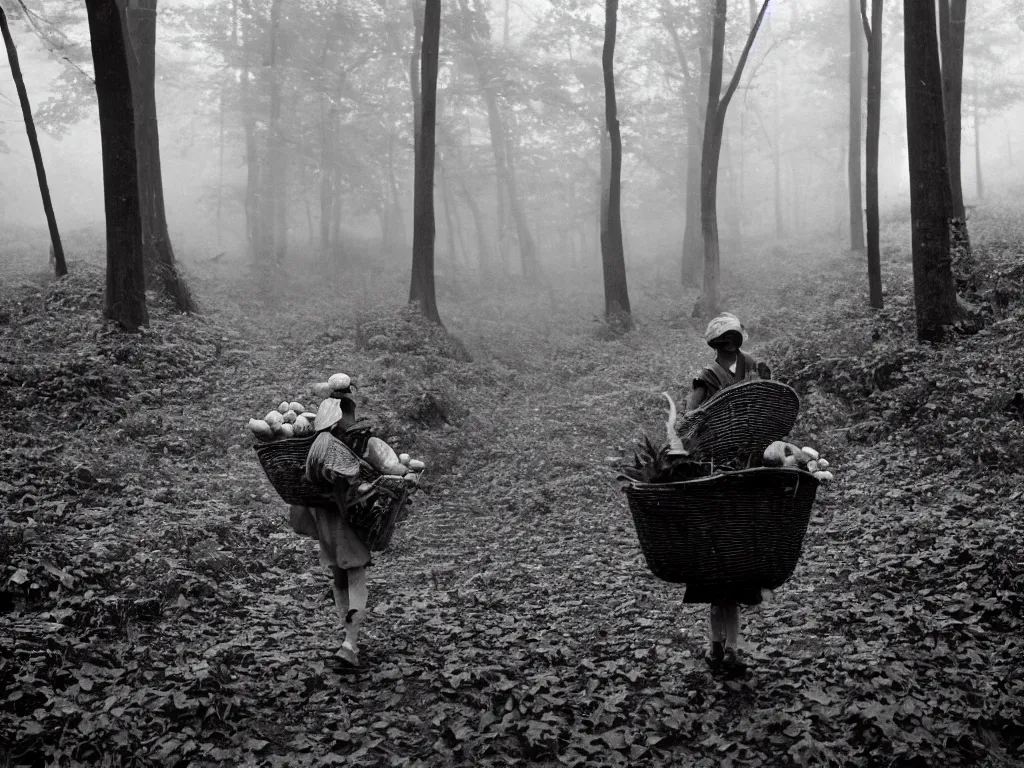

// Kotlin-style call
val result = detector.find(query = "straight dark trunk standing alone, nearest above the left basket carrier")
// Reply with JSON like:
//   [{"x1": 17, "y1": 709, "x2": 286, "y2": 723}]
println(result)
[{"x1": 409, "y1": 0, "x2": 441, "y2": 325}]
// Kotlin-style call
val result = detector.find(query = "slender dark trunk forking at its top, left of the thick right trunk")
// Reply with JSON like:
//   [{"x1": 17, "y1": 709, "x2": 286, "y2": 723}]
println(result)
[{"x1": 860, "y1": 0, "x2": 883, "y2": 309}]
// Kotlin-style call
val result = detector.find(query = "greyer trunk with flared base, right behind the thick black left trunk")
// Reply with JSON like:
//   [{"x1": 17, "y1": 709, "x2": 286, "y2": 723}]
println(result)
[{"x1": 127, "y1": 0, "x2": 196, "y2": 312}]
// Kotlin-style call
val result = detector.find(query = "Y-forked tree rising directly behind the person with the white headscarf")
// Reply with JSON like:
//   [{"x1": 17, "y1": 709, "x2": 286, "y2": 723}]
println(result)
[{"x1": 700, "y1": 0, "x2": 770, "y2": 316}]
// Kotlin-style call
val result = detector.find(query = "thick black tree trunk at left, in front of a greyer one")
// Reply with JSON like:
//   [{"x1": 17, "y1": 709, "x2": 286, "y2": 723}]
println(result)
[{"x1": 85, "y1": 0, "x2": 150, "y2": 332}]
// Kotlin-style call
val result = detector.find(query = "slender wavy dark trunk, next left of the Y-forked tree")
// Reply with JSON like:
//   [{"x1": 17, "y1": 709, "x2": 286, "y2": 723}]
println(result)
[{"x1": 601, "y1": 0, "x2": 630, "y2": 326}]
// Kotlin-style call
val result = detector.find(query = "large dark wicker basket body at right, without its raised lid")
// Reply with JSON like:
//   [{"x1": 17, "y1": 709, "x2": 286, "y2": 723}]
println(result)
[{"x1": 626, "y1": 468, "x2": 818, "y2": 589}]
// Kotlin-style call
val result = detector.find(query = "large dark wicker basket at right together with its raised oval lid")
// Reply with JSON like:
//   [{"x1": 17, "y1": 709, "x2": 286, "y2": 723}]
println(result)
[{"x1": 626, "y1": 381, "x2": 818, "y2": 589}]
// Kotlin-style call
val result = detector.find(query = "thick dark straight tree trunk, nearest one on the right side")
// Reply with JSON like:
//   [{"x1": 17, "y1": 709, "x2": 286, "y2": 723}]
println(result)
[{"x1": 903, "y1": 0, "x2": 958, "y2": 341}]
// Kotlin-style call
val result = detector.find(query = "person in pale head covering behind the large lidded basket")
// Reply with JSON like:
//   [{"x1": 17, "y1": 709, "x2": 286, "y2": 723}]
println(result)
[{"x1": 683, "y1": 312, "x2": 771, "y2": 673}]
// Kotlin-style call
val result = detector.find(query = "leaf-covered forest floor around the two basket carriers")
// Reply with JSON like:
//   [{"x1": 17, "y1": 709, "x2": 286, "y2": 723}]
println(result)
[{"x1": 6, "y1": 210, "x2": 1024, "y2": 766}]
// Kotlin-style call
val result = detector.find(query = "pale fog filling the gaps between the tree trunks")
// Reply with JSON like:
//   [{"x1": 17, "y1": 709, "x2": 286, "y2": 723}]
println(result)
[{"x1": 0, "y1": 0, "x2": 1024, "y2": 271}]
